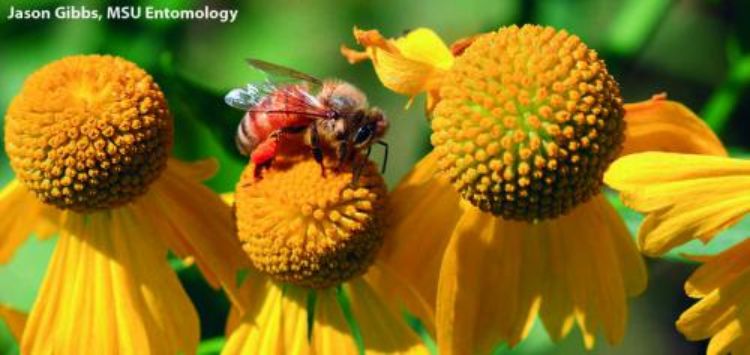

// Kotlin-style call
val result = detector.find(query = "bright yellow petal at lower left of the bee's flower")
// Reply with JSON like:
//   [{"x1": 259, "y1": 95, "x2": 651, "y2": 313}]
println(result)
[{"x1": 222, "y1": 282, "x2": 311, "y2": 355}]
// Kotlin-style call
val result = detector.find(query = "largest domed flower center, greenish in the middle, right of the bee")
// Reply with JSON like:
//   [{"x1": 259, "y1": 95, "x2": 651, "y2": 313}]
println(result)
[{"x1": 432, "y1": 25, "x2": 625, "y2": 221}]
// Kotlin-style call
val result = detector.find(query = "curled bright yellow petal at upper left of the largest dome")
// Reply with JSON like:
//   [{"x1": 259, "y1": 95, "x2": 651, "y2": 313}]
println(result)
[{"x1": 342, "y1": 28, "x2": 453, "y2": 96}]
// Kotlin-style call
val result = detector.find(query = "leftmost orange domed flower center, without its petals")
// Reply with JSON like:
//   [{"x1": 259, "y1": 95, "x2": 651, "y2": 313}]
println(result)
[{"x1": 5, "y1": 55, "x2": 172, "y2": 212}]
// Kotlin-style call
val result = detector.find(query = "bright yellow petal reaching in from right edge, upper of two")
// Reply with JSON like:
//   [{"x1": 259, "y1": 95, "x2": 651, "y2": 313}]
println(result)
[{"x1": 604, "y1": 152, "x2": 750, "y2": 255}]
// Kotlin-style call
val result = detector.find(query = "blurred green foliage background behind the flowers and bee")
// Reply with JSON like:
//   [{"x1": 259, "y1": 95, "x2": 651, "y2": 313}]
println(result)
[{"x1": 0, "y1": 0, "x2": 750, "y2": 354}]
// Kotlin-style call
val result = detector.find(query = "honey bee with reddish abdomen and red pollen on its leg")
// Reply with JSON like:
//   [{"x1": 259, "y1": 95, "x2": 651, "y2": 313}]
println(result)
[{"x1": 224, "y1": 59, "x2": 388, "y2": 178}]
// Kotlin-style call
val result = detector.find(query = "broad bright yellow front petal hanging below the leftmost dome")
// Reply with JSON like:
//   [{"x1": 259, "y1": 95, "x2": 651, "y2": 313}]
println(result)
[{"x1": 21, "y1": 209, "x2": 199, "y2": 354}]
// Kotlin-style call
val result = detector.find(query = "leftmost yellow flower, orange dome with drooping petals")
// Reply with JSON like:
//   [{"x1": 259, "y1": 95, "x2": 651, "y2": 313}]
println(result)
[{"x1": 0, "y1": 55, "x2": 253, "y2": 354}]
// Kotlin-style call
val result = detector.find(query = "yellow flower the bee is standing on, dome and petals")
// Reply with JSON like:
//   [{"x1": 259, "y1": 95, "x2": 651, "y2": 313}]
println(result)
[{"x1": 222, "y1": 154, "x2": 432, "y2": 354}]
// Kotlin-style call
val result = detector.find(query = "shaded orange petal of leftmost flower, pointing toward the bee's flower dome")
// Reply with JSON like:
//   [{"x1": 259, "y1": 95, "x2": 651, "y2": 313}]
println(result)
[{"x1": 134, "y1": 159, "x2": 249, "y2": 310}]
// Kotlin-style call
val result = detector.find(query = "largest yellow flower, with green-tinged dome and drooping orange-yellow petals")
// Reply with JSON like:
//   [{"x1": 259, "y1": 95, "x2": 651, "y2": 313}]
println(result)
[{"x1": 344, "y1": 25, "x2": 725, "y2": 354}]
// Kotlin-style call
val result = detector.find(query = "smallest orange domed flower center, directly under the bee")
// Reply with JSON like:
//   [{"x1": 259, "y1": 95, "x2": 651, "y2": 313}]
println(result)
[{"x1": 235, "y1": 157, "x2": 386, "y2": 288}]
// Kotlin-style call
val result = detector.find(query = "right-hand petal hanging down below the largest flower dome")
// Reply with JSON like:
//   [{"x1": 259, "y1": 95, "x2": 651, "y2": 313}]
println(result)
[{"x1": 542, "y1": 195, "x2": 646, "y2": 348}]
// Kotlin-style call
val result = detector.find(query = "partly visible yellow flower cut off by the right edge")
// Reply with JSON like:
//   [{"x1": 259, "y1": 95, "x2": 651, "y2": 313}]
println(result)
[{"x1": 605, "y1": 152, "x2": 750, "y2": 354}]
